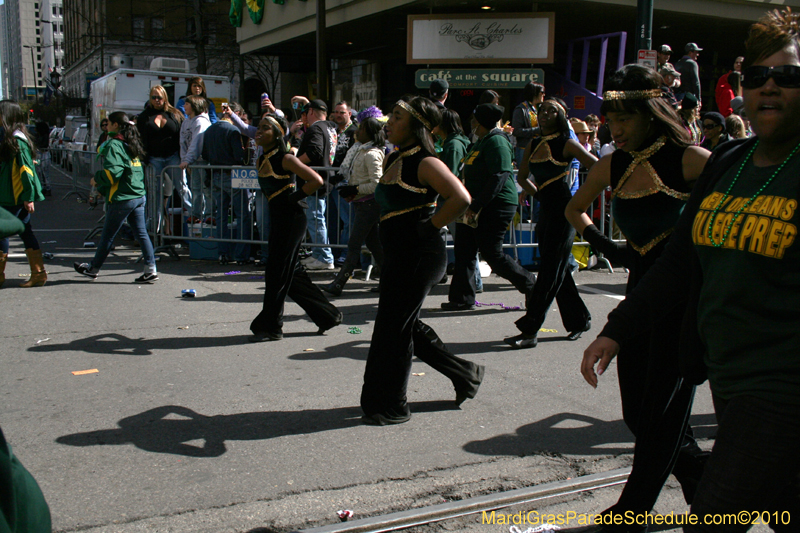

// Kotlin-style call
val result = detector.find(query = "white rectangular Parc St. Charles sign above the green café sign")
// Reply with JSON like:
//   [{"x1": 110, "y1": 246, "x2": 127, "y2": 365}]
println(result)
[{"x1": 406, "y1": 12, "x2": 555, "y2": 64}]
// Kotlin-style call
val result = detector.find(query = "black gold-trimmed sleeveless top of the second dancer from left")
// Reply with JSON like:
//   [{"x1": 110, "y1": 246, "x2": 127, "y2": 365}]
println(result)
[{"x1": 375, "y1": 145, "x2": 438, "y2": 221}]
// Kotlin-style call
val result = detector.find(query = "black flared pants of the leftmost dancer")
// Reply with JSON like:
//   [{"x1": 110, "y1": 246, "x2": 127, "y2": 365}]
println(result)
[{"x1": 250, "y1": 203, "x2": 341, "y2": 333}]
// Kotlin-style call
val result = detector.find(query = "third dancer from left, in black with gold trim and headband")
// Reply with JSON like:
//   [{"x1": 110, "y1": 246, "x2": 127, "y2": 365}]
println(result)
[{"x1": 505, "y1": 97, "x2": 597, "y2": 349}]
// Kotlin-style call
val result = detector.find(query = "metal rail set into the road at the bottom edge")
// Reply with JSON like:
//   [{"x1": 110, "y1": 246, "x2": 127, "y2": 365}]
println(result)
[{"x1": 293, "y1": 468, "x2": 631, "y2": 533}]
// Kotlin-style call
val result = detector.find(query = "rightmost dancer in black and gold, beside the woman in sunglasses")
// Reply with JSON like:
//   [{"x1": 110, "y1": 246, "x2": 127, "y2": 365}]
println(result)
[{"x1": 566, "y1": 65, "x2": 708, "y2": 531}]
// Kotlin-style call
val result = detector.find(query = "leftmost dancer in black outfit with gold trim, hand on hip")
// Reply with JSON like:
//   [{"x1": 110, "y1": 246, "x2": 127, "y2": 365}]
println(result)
[{"x1": 250, "y1": 114, "x2": 342, "y2": 342}]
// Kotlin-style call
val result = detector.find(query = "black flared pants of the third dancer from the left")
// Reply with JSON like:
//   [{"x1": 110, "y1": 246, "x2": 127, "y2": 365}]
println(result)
[{"x1": 516, "y1": 199, "x2": 592, "y2": 335}]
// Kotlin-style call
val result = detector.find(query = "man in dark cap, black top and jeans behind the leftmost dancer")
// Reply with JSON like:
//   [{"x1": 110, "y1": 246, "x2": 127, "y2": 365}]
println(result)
[{"x1": 297, "y1": 100, "x2": 338, "y2": 270}]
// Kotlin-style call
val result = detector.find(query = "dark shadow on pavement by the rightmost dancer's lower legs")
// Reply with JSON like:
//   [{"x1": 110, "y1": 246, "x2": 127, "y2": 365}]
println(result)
[{"x1": 464, "y1": 413, "x2": 716, "y2": 456}]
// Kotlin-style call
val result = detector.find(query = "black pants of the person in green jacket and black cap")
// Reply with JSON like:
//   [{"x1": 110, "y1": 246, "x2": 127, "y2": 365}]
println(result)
[{"x1": 448, "y1": 203, "x2": 534, "y2": 304}]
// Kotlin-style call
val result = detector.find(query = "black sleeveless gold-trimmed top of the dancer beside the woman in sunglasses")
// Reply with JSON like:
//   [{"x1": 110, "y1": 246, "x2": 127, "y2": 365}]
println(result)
[{"x1": 611, "y1": 137, "x2": 692, "y2": 256}]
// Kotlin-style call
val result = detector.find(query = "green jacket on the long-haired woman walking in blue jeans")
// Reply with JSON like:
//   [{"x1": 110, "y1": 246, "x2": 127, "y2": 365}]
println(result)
[{"x1": 94, "y1": 137, "x2": 145, "y2": 204}]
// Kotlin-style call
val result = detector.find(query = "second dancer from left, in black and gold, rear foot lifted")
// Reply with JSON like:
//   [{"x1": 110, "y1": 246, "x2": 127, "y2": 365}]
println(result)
[{"x1": 361, "y1": 97, "x2": 484, "y2": 425}]
